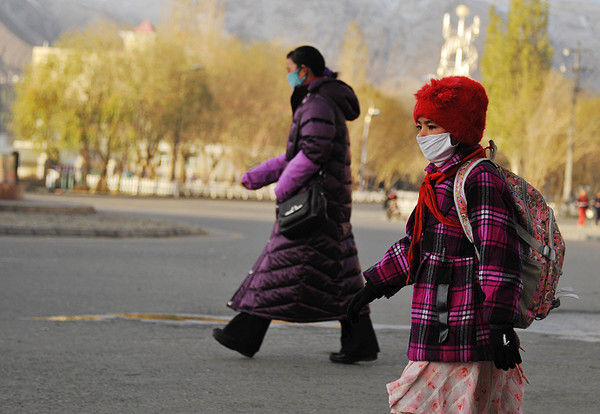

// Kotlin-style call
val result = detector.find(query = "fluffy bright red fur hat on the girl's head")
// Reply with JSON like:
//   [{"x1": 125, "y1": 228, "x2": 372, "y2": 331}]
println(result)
[{"x1": 413, "y1": 76, "x2": 488, "y2": 145}]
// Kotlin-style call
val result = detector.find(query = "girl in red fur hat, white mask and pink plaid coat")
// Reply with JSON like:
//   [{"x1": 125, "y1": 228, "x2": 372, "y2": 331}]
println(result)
[{"x1": 348, "y1": 76, "x2": 524, "y2": 414}]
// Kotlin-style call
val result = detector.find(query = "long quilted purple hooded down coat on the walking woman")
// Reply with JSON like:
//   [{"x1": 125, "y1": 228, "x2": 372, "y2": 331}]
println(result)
[{"x1": 228, "y1": 78, "x2": 368, "y2": 322}]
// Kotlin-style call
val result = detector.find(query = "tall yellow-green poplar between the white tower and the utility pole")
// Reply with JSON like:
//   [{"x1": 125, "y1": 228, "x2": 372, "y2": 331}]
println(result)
[{"x1": 481, "y1": 0, "x2": 553, "y2": 178}]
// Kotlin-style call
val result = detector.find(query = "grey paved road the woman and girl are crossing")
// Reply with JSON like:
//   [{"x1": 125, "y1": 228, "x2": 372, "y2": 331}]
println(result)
[{"x1": 0, "y1": 196, "x2": 600, "y2": 414}]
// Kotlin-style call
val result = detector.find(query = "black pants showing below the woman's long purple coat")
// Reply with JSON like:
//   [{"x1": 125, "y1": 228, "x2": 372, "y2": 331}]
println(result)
[{"x1": 223, "y1": 313, "x2": 379, "y2": 356}]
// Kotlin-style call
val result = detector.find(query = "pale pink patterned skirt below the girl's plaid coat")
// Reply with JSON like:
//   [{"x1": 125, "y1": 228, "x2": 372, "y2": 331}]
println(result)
[{"x1": 387, "y1": 361, "x2": 527, "y2": 414}]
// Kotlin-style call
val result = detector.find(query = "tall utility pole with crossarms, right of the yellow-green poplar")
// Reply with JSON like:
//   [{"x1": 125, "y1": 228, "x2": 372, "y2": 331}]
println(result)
[{"x1": 560, "y1": 42, "x2": 591, "y2": 214}]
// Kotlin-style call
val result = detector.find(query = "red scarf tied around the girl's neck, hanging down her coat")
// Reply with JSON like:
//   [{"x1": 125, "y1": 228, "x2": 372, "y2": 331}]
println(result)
[{"x1": 406, "y1": 146, "x2": 486, "y2": 285}]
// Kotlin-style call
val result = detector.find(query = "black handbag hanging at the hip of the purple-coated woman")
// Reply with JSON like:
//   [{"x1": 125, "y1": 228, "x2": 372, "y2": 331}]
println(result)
[{"x1": 278, "y1": 172, "x2": 327, "y2": 239}]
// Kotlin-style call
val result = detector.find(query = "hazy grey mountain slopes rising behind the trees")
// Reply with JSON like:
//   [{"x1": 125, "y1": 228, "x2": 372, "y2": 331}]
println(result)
[{"x1": 0, "y1": 0, "x2": 600, "y2": 92}]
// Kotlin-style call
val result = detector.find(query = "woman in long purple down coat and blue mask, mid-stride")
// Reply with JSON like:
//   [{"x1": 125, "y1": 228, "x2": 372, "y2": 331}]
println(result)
[{"x1": 213, "y1": 46, "x2": 379, "y2": 364}]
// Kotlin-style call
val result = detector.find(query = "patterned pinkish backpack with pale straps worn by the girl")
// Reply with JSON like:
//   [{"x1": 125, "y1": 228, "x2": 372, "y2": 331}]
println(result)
[{"x1": 454, "y1": 141, "x2": 576, "y2": 328}]
